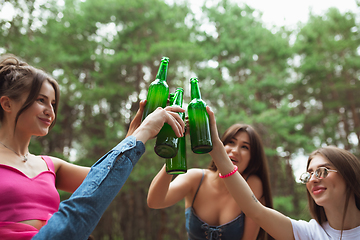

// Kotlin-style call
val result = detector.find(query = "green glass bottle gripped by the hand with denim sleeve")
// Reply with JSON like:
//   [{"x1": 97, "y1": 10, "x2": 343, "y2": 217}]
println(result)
[{"x1": 154, "y1": 88, "x2": 185, "y2": 158}]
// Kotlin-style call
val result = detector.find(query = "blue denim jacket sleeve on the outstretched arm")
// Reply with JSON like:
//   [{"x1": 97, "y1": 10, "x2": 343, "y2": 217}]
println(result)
[{"x1": 32, "y1": 136, "x2": 145, "y2": 240}]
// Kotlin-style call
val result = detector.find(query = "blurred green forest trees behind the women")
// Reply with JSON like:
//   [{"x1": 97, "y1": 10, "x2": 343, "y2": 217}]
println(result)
[{"x1": 0, "y1": 0, "x2": 360, "y2": 240}]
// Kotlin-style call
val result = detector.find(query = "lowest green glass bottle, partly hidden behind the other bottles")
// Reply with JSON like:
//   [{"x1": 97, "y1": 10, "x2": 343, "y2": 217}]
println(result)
[{"x1": 166, "y1": 114, "x2": 187, "y2": 174}]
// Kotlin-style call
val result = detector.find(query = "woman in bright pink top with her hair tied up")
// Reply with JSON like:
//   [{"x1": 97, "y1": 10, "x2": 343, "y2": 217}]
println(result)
[{"x1": 0, "y1": 56, "x2": 74, "y2": 234}]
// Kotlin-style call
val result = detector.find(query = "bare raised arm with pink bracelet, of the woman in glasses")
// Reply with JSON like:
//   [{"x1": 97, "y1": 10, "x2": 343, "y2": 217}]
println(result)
[{"x1": 207, "y1": 107, "x2": 295, "y2": 240}]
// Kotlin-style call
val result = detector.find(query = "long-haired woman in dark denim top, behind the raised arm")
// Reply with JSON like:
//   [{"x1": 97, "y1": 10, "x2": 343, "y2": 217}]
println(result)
[{"x1": 147, "y1": 124, "x2": 272, "y2": 240}]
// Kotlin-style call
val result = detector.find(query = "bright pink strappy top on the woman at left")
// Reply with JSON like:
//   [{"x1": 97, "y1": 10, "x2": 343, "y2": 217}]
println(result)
[{"x1": 0, "y1": 156, "x2": 60, "y2": 222}]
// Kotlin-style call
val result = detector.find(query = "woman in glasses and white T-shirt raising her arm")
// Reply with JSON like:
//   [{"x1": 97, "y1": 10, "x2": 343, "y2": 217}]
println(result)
[{"x1": 207, "y1": 107, "x2": 360, "y2": 240}]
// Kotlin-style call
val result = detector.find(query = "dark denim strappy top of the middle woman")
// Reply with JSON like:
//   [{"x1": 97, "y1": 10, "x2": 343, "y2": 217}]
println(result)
[{"x1": 185, "y1": 170, "x2": 245, "y2": 240}]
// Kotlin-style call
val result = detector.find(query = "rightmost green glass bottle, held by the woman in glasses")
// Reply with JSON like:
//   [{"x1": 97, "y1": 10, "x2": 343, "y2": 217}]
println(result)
[{"x1": 187, "y1": 78, "x2": 212, "y2": 154}]
